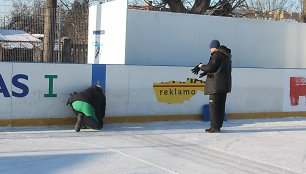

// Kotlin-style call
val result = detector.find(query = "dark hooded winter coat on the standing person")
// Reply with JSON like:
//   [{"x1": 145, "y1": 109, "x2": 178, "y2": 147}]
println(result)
[{"x1": 201, "y1": 46, "x2": 232, "y2": 95}]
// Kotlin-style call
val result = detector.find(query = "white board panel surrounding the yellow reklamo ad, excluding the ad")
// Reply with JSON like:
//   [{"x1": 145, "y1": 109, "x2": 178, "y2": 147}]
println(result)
[{"x1": 125, "y1": 66, "x2": 208, "y2": 115}]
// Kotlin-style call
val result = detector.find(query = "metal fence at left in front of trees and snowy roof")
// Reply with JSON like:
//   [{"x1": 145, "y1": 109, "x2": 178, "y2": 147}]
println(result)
[{"x1": 0, "y1": 7, "x2": 88, "y2": 63}]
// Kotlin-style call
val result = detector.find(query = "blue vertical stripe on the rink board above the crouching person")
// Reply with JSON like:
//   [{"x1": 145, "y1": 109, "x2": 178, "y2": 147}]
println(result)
[{"x1": 91, "y1": 64, "x2": 106, "y2": 92}]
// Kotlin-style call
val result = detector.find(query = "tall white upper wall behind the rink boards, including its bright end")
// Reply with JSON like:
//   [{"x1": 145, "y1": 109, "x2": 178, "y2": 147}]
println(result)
[{"x1": 88, "y1": 0, "x2": 306, "y2": 68}]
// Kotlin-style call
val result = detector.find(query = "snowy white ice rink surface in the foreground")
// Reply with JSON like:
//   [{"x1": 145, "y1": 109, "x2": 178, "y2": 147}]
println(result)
[{"x1": 0, "y1": 117, "x2": 306, "y2": 174}]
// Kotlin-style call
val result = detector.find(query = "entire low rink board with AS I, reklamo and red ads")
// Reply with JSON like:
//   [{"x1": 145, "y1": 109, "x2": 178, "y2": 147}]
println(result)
[{"x1": 0, "y1": 63, "x2": 306, "y2": 125}]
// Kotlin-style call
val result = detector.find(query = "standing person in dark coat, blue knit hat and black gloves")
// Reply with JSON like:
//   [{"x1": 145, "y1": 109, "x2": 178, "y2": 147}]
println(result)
[{"x1": 192, "y1": 40, "x2": 232, "y2": 133}]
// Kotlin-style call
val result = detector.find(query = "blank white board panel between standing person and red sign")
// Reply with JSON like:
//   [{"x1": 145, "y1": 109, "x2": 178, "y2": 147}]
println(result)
[{"x1": 226, "y1": 68, "x2": 283, "y2": 113}]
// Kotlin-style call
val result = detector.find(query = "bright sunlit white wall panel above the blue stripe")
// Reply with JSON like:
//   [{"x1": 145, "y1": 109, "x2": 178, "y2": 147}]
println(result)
[{"x1": 88, "y1": 0, "x2": 127, "y2": 64}]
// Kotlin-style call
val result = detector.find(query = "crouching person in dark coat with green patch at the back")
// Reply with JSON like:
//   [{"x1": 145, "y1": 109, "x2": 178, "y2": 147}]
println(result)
[{"x1": 67, "y1": 85, "x2": 106, "y2": 132}]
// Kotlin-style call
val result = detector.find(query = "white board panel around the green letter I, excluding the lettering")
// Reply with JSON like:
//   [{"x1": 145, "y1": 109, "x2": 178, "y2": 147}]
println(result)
[{"x1": 12, "y1": 63, "x2": 91, "y2": 118}]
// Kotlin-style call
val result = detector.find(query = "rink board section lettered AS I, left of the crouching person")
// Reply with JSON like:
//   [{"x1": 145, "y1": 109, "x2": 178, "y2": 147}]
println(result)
[{"x1": 0, "y1": 63, "x2": 105, "y2": 125}]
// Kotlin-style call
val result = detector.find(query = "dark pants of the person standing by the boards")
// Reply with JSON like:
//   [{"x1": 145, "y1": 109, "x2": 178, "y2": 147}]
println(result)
[{"x1": 209, "y1": 93, "x2": 227, "y2": 129}]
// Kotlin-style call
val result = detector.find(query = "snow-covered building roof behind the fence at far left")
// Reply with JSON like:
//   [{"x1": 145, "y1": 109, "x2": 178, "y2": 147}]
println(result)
[{"x1": 0, "y1": 29, "x2": 42, "y2": 49}]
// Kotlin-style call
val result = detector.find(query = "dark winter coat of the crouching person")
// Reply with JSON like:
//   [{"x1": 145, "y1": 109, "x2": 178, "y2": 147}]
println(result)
[{"x1": 67, "y1": 86, "x2": 106, "y2": 123}]
